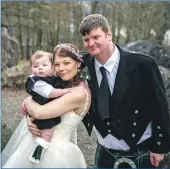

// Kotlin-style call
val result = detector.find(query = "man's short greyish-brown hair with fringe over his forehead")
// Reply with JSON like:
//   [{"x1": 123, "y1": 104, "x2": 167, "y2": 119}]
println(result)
[{"x1": 79, "y1": 14, "x2": 110, "y2": 36}]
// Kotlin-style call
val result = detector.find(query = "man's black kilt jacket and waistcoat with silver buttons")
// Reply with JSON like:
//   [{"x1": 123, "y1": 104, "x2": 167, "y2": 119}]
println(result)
[{"x1": 83, "y1": 46, "x2": 170, "y2": 153}]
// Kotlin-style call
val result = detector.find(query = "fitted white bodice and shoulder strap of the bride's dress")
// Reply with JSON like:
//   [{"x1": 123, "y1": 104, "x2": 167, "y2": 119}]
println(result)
[{"x1": 51, "y1": 88, "x2": 89, "y2": 144}]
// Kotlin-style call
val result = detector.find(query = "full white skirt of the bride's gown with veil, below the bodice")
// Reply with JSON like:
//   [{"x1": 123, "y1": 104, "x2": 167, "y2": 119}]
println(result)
[{"x1": 3, "y1": 133, "x2": 86, "y2": 168}]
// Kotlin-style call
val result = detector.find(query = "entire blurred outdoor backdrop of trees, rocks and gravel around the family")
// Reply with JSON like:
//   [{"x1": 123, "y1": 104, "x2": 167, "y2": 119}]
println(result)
[{"x1": 1, "y1": 1, "x2": 170, "y2": 168}]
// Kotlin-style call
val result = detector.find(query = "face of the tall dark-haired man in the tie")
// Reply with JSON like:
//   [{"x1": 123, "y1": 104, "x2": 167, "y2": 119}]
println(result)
[{"x1": 83, "y1": 27, "x2": 112, "y2": 57}]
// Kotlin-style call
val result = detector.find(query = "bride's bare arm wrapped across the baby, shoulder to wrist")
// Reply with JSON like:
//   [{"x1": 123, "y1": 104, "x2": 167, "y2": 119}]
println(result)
[{"x1": 26, "y1": 88, "x2": 86, "y2": 119}]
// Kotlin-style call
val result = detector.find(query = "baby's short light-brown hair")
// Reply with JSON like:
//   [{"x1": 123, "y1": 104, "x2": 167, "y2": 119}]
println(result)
[{"x1": 30, "y1": 50, "x2": 53, "y2": 66}]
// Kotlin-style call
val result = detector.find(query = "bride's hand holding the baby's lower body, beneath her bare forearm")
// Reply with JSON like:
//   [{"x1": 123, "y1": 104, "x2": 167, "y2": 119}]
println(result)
[{"x1": 27, "y1": 117, "x2": 42, "y2": 137}]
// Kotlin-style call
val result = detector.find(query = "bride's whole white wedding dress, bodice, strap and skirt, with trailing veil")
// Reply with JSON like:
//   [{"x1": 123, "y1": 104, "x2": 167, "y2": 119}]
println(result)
[{"x1": 2, "y1": 88, "x2": 88, "y2": 168}]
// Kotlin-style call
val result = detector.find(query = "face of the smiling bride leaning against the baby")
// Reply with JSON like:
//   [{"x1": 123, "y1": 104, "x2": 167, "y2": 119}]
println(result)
[{"x1": 54, "y1": 54, "x2": 81, "y2": 81}]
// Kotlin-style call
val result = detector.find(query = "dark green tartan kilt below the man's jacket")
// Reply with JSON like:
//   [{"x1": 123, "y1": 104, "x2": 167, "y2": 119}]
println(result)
[{"x1": 94, "y1": 143, "x2": 155, "y2": 168}]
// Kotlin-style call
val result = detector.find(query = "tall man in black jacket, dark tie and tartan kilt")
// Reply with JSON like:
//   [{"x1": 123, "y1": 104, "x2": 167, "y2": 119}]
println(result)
[{"x1": 79, "y1": 14, "x2": 170, "y2": 168}]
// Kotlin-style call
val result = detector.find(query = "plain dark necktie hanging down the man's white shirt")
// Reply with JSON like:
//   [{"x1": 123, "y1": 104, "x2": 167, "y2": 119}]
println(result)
[{"x1": 98, "y1": 67, "x2": 111, "y2": 119}]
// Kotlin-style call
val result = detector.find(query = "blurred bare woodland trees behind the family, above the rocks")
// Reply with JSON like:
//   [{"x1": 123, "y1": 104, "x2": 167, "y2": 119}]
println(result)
[{"x1": 1, "y1": 1, "x2": 170, "y2": 66}]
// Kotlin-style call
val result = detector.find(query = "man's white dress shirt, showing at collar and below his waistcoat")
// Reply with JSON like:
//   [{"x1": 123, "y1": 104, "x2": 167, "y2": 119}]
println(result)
[{"x1": 93, "y1": 46, "x2": 152, "y2": 151}]
